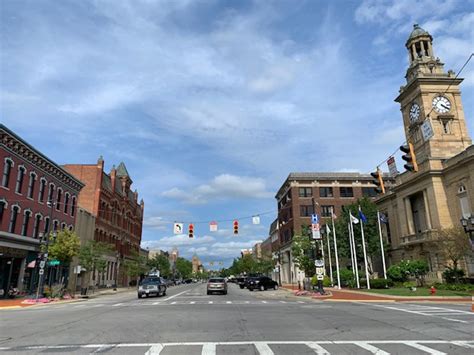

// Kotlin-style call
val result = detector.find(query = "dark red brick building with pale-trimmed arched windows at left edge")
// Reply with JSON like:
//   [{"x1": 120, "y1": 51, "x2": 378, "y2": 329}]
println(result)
[{"x1": 0, "y1": 124, "x2": 84, "y2": 293}]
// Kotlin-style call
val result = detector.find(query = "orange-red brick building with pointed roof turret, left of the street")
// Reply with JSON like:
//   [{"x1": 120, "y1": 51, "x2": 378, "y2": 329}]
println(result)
[{"x1": 64, "y1": 157, "x2": 144, "y2": 286}]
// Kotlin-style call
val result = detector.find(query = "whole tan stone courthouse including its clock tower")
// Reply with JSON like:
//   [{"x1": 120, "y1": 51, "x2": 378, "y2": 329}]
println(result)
[{"x1": 376, "y1": 25, "x2": 474, "y2": 278}]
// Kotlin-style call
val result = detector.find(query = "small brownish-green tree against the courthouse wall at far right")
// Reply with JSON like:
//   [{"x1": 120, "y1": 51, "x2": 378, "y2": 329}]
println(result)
[{"x1": 434, "y1": 227, "x2": 472, "y2": 282}]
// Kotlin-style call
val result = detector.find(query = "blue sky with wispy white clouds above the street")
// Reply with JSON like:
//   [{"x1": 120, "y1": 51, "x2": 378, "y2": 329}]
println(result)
[{"x1": 0, "y1": 0, "x2": 474, "y2": 267}]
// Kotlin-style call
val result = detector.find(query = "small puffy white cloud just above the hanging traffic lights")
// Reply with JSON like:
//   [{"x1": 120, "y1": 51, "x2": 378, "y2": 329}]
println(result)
[{"x1": 162, "y1": 174, "x2": 273, "y2": 204}]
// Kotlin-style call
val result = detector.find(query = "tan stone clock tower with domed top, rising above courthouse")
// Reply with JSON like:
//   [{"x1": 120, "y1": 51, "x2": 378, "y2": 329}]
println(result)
[{"x1": 395, "y1": 24, "x2": 472, "y2": 171}]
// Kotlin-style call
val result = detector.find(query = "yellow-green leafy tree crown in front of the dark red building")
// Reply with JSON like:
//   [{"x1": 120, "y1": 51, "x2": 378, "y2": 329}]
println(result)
[{"x1": 43, "y1": 229, "x2": 80, "y2": 265}]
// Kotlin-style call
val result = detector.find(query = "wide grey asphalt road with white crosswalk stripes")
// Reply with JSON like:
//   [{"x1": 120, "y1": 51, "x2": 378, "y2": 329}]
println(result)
[{"x1": 0, "y1": 284, "x2": 474, "y2": 355}]
